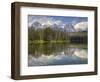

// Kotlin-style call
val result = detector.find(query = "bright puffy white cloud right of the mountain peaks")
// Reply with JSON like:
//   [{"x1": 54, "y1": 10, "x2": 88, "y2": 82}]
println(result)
[{"x1": 74, "y1": 22, "x2": 88, "y2": 31}]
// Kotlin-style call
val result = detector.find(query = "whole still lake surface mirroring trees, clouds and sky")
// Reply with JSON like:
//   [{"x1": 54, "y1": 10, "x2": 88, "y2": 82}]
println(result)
[{"x1": 28, "y1": 43, "x2": 88, "y2": 66}]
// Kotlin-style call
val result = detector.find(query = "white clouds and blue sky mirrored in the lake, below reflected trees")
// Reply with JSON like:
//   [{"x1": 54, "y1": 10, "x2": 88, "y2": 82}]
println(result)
[{"x1": 28, "y1": 48, "x2": 87, "y2": 66}]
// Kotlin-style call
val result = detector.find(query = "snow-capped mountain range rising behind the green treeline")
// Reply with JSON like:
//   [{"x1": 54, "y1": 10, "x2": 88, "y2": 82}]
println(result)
[{"x1": 31, "y1": 21, "x2": 86, "y2": 32}]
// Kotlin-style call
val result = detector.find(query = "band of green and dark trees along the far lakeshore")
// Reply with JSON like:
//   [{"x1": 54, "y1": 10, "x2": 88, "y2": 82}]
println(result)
[{"x1": 28, "y1": 27, "x2": 87, "y2": 43}]
